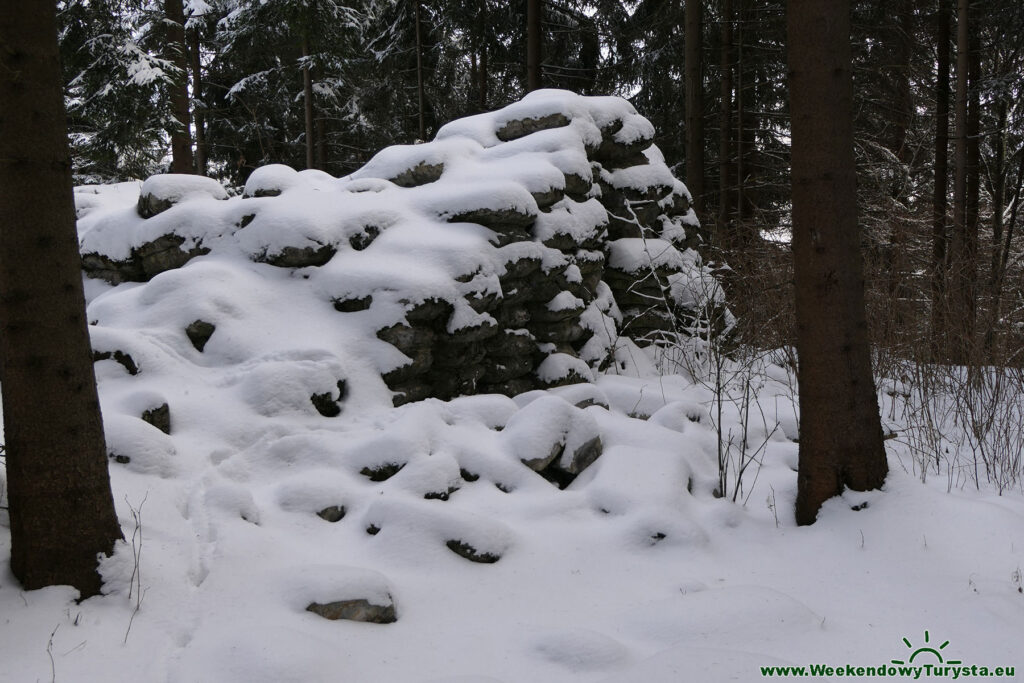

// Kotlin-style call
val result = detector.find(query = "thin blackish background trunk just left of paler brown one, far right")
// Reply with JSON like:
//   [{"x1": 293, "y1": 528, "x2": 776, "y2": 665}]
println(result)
[{"x1": 931, "y1": 0, "x2": 949, "y2": 359}]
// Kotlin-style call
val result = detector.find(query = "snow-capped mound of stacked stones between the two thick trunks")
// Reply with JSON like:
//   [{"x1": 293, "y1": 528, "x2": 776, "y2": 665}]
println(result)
[{"x1": 77, "y1": 90, "x2": 728, "y2": 415}]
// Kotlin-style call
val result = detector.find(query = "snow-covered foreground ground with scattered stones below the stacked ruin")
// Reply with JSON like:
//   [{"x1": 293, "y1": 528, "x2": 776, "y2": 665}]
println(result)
[{"x1": 0, "y1": 358, "x2": 1024, "y2": 683}]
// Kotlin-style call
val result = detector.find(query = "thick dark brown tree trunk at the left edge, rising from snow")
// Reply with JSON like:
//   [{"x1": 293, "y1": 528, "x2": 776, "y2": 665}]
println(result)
[{"x1": 0, "y1": 0, "x2": 122, "y2": 598}]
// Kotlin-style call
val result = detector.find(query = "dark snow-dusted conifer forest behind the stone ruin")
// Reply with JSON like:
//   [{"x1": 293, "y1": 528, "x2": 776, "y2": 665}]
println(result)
[{"x1": 58, "y1": 0, "x2": 1024, "y2": 377}]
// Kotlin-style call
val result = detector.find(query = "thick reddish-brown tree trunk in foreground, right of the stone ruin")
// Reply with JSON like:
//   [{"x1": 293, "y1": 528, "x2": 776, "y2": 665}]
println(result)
[{"x1": 786, "y1": 0, "x2": 888, "y2": 524}]
